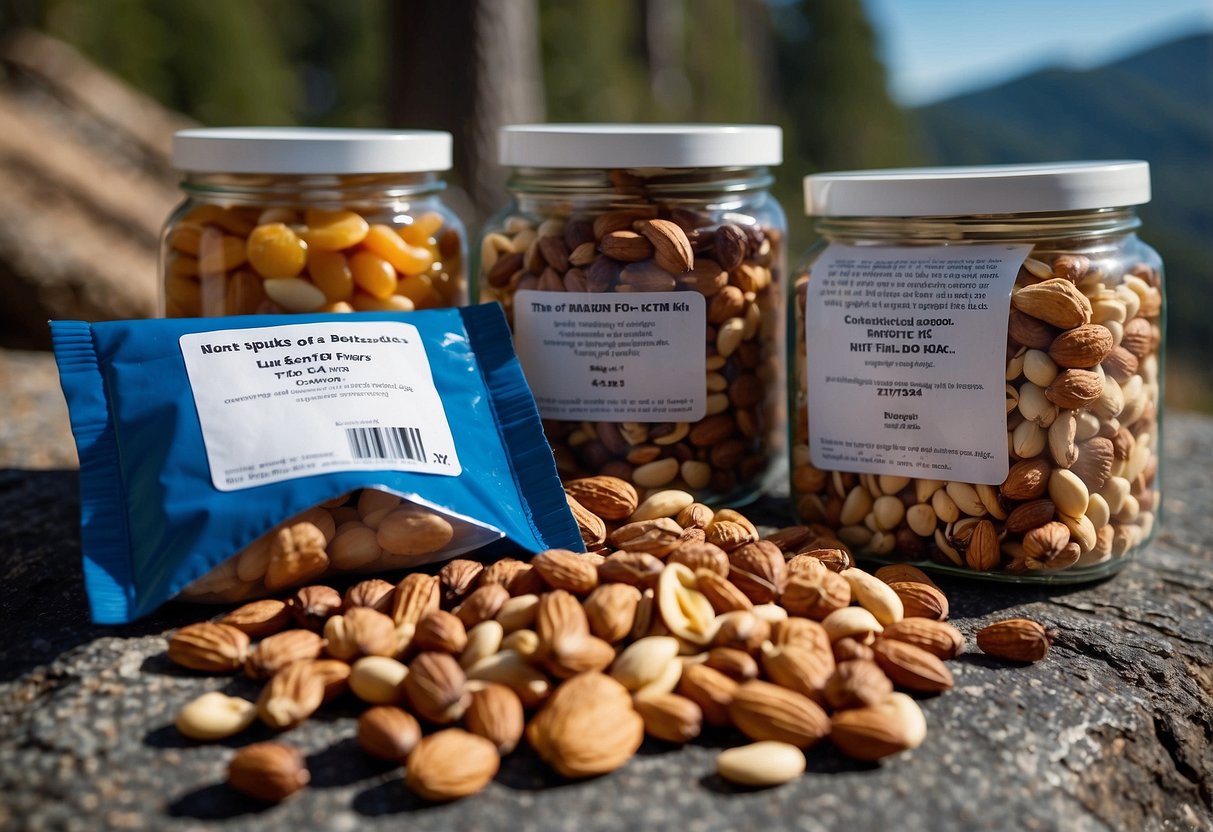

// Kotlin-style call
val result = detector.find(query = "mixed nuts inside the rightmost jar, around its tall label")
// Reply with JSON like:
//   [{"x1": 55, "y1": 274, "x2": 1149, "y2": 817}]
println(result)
[{"x1": 792, "y1": 249, "x2": 1162, "y2": 574}]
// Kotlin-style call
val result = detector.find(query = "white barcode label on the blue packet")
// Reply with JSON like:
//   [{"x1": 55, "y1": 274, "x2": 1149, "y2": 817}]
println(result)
[{"x1": 181, "y1": 321, "x2": 462, "y2": 491}]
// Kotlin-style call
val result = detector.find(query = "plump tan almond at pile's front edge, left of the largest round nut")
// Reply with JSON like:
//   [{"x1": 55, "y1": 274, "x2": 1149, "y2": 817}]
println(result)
[{"x1": 404, "y1": 728, "x2": 501, "y2": 802}]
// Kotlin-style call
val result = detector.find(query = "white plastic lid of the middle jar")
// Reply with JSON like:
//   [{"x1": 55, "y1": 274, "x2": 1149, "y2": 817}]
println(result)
[{"x1": 497, "y1": 124, "x2": 784, "y2": 167}]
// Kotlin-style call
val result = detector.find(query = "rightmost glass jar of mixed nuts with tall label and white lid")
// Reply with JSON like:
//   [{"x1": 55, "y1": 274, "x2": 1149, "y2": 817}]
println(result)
[{"x1": 788, "y1": 161, "x2": 1164, "y2": 582}]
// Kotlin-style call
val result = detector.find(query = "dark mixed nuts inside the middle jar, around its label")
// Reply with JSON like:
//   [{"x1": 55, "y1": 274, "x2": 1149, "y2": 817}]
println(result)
[{"x1": 479, "y1": 177, "x2": 784, "y2": 503}]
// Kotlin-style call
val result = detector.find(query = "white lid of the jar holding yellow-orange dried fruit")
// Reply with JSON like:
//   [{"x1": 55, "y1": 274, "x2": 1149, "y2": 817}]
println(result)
[{"x1": 172, "y1": 127, "x2": 451, "y2": 175}]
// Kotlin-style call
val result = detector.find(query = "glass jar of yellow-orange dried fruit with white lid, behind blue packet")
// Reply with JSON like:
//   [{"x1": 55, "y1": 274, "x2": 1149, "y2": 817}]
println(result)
[{"x1": 160, "y1": 127, "x2": 467, "y2": 318}]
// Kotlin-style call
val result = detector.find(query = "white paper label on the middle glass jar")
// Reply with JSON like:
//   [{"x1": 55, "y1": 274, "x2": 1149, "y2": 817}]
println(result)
[{"x1": 514, "y1": 291, "x2": 707, "y2": 422}]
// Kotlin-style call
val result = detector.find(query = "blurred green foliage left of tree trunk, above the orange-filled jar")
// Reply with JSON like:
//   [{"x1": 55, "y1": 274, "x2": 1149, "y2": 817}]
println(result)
[{"x1": 0, "y1": 0, "x2": 387, "y2": 125}]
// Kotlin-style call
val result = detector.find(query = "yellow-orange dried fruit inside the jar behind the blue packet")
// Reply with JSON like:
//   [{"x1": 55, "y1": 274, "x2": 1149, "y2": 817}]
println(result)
[{"x1": 164, "y1": 203, "x2": 466, "y2": 318}]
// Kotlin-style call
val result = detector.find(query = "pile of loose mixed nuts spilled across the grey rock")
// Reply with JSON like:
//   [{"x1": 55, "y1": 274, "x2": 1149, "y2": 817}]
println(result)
[{"x1": 167, "y1": 477, "x2": 1049, "y2": 800}]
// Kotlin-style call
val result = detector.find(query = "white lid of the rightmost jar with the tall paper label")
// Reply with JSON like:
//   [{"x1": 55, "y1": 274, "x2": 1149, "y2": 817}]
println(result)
[{"x1": 804, "y1": 160, "x2": 1150, "y2": 217}]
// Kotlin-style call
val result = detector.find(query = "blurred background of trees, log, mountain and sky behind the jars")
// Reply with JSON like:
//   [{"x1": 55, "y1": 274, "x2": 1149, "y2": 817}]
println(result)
[{"x1": 0, "y1": 0, "x2": 1213, "y2": 411}]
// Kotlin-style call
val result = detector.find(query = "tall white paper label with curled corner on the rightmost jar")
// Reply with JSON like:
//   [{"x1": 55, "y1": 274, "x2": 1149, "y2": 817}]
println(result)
[{"x1": 804, "y1": 245, "x2": 1031, "y2": 485}]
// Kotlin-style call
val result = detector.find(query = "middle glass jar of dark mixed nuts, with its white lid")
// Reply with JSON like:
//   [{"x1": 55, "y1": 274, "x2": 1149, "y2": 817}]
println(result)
[{"x1": 478, "y1": 125, "x2": 786, "y2": 505}]
